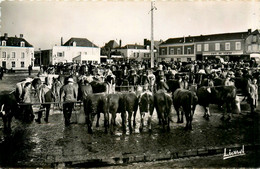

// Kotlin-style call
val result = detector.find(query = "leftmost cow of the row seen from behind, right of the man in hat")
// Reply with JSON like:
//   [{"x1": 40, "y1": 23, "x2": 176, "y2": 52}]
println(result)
[{"x1": 83, "y1": 93, "x2": 109, "y2": 134}]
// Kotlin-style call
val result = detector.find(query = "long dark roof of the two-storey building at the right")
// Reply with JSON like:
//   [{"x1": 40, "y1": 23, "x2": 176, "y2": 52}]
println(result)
[{"x1": 162, "y1": 32, "x2": 249, "y2": 45}]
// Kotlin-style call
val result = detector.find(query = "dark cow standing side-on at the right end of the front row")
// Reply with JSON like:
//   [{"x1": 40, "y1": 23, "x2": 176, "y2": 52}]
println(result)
[{"x1": 197, "y1": 86, "x2": 240, "y2": 120}]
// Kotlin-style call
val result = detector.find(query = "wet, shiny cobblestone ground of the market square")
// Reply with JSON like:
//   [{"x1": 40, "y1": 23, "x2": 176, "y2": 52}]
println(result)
[{"x1": 0, "y1": 75, "x2": 260, "y2": 167}]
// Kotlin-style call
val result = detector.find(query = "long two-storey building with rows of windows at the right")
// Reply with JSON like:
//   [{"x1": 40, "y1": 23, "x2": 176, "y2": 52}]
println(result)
[{"x1": 158, "y1": 29, "x2": 260, "y2": 62}]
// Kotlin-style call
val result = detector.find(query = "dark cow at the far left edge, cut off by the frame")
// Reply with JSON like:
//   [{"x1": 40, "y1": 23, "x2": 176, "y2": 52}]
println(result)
[{"x1": 0, "y1": 92, "x2": 19, "y2": 133}]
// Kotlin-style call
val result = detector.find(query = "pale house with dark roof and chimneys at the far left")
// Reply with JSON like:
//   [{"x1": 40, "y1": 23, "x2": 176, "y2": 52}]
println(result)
[{"x1": 0, "y1": 33, "x2": 34, "y2": 70}]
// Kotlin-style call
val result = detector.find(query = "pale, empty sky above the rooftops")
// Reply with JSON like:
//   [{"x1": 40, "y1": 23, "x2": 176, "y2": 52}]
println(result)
[{"x1": 0, "y1": 0, "x2": 260, "y2": 50}]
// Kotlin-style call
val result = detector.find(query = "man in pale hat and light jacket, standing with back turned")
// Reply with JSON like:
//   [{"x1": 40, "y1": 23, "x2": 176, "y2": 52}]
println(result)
[{"x1": 60, "y1": 78, "x2": 78, "y2": 126}]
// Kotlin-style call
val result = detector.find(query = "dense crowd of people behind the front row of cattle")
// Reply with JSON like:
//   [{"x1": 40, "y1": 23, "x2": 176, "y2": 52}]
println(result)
[{"x1": 17, "y1": 58, "x2": 259, "y2": 126}]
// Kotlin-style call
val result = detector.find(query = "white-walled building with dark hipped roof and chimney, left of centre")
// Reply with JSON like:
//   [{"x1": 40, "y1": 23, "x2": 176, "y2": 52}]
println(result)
[{"x1": 50, "y1": 38, "x2": 100, "y2": 64}]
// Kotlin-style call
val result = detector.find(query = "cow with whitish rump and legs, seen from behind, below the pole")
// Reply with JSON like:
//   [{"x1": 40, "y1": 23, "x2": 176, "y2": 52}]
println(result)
[{"x1": 139, "y1": 92, "x2": 154, "y2": 132}]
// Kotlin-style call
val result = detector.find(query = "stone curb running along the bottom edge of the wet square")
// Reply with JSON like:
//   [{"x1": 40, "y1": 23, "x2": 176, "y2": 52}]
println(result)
[{"x1": 47, "y1": 144, "x2": 260, "y2": 168}]
